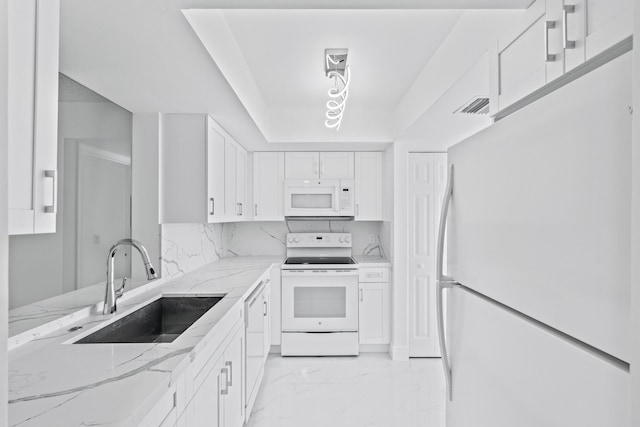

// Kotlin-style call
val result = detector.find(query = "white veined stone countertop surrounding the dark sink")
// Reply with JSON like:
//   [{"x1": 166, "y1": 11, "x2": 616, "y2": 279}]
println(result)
[{"x1": 8, "y1": 257, "x2": 282, "y2": 427}]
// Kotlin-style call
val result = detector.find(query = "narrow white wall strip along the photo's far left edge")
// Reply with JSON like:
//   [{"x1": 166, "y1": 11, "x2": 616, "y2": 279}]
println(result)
[{"x1": 0, "y1": 0, "x2": 9, "y2": 427}]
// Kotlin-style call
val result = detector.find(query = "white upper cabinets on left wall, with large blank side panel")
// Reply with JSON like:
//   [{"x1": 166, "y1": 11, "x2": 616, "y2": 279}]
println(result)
[{"x1": 160, "y1": 114, "x2": 247, "y2": 224}]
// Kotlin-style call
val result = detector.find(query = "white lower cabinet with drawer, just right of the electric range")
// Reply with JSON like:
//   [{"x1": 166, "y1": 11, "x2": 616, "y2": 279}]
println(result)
[{"x1": 358, "y1": 267, "x2": 390, "y2": 344}]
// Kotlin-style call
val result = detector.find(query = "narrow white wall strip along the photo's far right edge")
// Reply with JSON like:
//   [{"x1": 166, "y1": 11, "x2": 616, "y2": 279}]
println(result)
[{"x1": 631, "y1": 1, "x2": 640, "y2": 426}]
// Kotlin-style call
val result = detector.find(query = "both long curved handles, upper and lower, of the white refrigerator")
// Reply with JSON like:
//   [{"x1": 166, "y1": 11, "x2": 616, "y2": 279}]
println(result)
[{"x1": 436, "y1": 165, "x2": 458, "y2": 400}]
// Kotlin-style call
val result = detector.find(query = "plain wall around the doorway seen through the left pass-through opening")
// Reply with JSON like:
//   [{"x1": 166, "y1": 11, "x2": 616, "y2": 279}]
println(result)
[{"x1": 9, "y1": 102, "x2": 132, "y2": 308}]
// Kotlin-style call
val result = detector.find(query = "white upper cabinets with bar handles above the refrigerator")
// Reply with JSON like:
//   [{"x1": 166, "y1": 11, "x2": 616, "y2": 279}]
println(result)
[{"x1": 491, "y1": 0, "x2": 633, "y2": 115}]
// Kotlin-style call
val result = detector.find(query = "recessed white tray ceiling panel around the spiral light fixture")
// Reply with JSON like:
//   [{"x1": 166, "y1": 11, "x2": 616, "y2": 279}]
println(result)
[{"x1": 185, "y1": 10, "x2": 463, "y2": 142}]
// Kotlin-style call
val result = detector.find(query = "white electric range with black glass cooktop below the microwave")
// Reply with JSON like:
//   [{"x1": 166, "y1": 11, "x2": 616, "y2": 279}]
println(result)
[{"x1": 281, "y1": 233, "x2": 359, "y2": 356}]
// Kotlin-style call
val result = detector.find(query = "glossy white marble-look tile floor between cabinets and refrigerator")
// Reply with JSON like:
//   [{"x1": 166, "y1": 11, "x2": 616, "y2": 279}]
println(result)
[{"x1": 246, "y1": 353, "x2": 445, "y2": 427}]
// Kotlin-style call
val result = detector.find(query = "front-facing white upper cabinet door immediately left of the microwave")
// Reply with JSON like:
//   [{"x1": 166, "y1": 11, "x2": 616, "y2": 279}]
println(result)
[{"x1": 253, "y1": 152, "x2": 284, "y2": 221}]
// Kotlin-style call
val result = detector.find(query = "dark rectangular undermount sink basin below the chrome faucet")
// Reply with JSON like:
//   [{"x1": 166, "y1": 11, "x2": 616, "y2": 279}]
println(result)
[{"x1": 74, "y1": 296, "x2": 223, "y2": 344}]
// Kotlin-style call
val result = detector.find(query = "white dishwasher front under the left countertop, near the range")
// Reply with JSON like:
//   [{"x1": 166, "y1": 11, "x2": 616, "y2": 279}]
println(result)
[{"x1": 244, "y1": 279, "x2": 270, "y2": 418}]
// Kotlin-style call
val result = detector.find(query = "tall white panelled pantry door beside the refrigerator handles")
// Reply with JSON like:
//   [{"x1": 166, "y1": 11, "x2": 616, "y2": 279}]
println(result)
[{"x1": 407, "y1": 153, "x2": 447, "y2": 357}]
